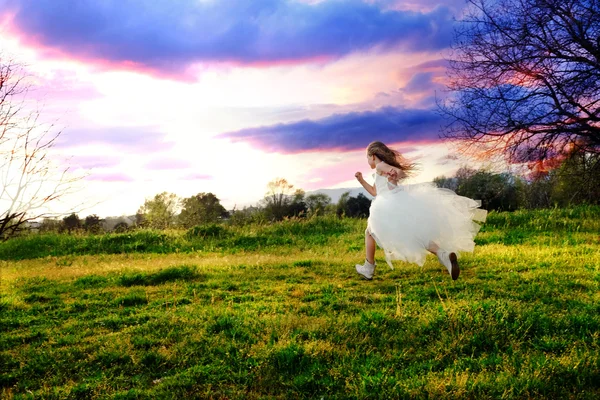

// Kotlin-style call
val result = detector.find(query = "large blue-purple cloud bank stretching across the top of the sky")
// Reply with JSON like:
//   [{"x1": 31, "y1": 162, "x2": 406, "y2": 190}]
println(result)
[{"x1": 0, "y1": 0, "x2": 453, "y2": 75}]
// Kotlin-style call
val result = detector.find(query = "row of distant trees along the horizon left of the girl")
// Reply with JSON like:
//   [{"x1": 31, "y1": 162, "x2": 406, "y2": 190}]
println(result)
[{"x1": 39, "y1": 178, "x2": 371, "y2": 233}]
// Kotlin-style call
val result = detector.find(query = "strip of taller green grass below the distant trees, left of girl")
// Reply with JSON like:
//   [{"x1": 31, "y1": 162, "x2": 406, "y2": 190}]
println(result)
[{"x1": 0, "y1": 216, "x2": 352, "y2": 260}]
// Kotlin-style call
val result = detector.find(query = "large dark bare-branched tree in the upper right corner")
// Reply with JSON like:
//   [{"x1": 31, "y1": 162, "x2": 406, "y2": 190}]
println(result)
[{"x1": 439, "y1": 0, "x2": 600, "y2": 163}]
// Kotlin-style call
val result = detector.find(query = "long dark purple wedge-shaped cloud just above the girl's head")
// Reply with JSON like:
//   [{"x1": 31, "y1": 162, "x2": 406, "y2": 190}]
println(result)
[{"x1": 217, "y1": 107, "x2": 442, "y2": 153}]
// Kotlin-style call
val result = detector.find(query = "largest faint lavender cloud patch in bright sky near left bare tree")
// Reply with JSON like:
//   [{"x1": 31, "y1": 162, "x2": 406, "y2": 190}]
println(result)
[{"x1": 56, "y1": 127, "x2": 173, "y2": 152}]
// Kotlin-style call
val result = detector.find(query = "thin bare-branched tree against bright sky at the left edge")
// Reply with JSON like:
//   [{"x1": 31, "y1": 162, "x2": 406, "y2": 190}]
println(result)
[{"x1": 0, "y1": 56, "x2": 81, "y2": 240}]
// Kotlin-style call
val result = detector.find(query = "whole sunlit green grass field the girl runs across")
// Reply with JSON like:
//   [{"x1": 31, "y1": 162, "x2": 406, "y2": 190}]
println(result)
[{"x1": 0, "y1": 207, "x2": 600, "y2": 399}]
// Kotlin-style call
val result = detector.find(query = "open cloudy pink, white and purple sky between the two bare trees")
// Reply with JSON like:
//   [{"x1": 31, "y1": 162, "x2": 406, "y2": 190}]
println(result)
[{"x1": 0, "y1": 0, "x2": 476, "y2": 217}]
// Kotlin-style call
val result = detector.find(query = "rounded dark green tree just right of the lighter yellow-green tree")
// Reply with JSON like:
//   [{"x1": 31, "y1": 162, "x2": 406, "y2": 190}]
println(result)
[{"x1": 179, "y1": 193, "x2": 227, "y2": 228}]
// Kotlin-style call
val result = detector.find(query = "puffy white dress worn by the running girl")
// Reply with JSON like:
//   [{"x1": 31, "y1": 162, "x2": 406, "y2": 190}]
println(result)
[{"x1": 367, "y1": 173, "x2": 487, "y2": 268}]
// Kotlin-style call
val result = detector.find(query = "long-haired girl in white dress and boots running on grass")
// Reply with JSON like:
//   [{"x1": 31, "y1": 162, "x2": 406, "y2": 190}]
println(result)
[{"x1": 355, "y1": 142, "x2": 487, "y2": 280}]
